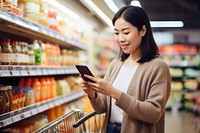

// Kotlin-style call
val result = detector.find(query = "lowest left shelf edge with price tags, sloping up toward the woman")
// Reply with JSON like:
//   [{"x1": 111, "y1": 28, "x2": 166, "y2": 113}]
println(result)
[{"x1": 0, "y1": 90, "x2": 85, "y2": 128}]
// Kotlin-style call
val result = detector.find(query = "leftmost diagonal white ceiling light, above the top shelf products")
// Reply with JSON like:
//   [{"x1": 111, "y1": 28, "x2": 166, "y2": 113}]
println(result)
[{"x1": 46, "y1": 0, "x2": 80, "y2": 20}]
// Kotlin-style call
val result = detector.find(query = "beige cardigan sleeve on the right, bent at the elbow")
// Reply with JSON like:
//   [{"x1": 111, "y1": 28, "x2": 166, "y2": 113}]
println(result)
[{"x1": 116, "y1": 61, "x2": 171, "y2": 124}]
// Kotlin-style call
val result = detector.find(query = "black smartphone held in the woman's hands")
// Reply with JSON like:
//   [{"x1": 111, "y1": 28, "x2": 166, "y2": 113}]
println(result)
[{"x1": 75, "y1": 65, "x2": 94, "y2": 82}]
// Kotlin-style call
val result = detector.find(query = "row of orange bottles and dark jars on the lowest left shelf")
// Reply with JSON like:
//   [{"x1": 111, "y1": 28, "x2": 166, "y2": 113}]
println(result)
[{"x1": 0, "y1": 76, "x2": 81, "y2": 114}]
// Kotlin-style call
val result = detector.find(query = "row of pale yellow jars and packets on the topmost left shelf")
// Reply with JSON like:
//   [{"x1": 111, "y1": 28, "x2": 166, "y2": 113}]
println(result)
[{"x1": 0, "y1": 0, "x2": 87, "y2": 43}]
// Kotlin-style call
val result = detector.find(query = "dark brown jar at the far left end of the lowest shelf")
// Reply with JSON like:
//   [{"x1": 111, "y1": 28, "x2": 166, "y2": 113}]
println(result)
[{"x1": 0, "y1": 85, "x2": 9, "y2": 114}]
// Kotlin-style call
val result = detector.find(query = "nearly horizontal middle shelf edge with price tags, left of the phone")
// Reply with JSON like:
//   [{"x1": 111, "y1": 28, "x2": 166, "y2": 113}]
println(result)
[{"x1": 0, "y1": 65, "x2": 78, "y2": 77}]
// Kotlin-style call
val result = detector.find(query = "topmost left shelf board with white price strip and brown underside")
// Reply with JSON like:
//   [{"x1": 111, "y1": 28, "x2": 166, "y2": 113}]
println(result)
[{"x1": 0, "y1": 10, "x2": 87, "y2": 50}]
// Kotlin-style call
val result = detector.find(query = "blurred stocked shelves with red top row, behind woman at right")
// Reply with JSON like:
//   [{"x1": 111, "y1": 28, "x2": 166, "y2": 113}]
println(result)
[{"x1": 159, "y1": 44, "x2": 200, "y2": 110}]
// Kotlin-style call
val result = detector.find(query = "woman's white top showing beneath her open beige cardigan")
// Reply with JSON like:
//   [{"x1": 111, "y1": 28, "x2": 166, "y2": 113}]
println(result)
[{"x1": 110, "y1": 65, "x2": 138, "y2": 123}]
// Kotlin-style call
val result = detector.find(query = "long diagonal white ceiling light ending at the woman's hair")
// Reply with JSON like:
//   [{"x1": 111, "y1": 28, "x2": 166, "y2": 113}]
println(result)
[{"x1": 81, "y1": 0, "x2": 113, "y2": 27}]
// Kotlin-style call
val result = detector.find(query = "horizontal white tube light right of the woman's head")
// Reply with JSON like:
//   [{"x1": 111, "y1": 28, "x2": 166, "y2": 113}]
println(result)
[{"x1": 150, "y1": 21, "x2": 184, "y2": 28}]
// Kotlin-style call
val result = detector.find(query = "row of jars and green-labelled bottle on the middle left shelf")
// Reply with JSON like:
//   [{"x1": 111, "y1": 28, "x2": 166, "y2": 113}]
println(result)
[{"x1": 0, "y1": 38, "x2": 80, "y2": 66}]
